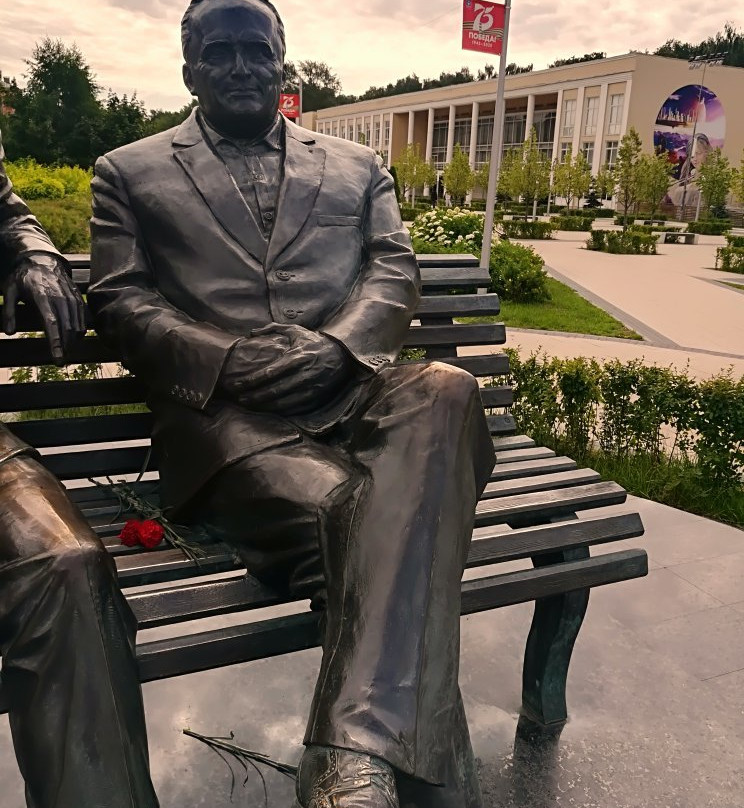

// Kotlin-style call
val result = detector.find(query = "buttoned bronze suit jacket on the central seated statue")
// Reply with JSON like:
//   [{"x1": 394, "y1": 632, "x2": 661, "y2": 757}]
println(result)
[{"x1": 88, "y1": 113, "x2": 420, "y2": 507}]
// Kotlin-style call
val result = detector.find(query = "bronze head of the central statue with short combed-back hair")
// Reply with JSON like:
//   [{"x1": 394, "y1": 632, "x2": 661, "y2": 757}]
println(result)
[{"x1": 182, "y1": 0, "x2": 286, "y2": 136}]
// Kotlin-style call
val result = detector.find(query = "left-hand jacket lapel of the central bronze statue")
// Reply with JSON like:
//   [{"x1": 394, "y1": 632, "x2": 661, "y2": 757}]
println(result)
[{"x1": 173, "y1": 111, "x2": 266, "y2": 264}]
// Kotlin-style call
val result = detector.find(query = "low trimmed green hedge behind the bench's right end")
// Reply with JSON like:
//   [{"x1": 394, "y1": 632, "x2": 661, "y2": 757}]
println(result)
[{"x1": 500, "y1": 350, "x2": 744, "y2": 519}]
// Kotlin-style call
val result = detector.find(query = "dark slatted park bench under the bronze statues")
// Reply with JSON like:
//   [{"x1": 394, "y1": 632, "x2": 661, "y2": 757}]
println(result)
[{"x1": 0, "y1": 256, "x2": 647, "y2": 725}]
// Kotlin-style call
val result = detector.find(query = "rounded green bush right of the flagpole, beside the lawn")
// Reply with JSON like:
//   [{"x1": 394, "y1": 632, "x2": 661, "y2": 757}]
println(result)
[{"x1": 489, "y1": 239, "x2": 550, "y2": 303}]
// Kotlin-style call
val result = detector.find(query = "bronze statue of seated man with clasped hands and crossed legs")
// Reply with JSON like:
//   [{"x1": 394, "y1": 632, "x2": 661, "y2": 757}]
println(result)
[{"x1": 88, "y1": 0, "x2": 494, "y2": 808}]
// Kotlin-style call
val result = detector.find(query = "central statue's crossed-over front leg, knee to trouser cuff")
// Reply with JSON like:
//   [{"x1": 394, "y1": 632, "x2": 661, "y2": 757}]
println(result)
[{"x1": 306, "y1": 363, "x2": 494, "y2": 784}]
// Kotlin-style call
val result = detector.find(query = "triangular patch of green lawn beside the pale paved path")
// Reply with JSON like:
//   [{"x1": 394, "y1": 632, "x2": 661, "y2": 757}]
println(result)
[{"x1": 464, "y1": 278, "x2": 642, "y2": 339}]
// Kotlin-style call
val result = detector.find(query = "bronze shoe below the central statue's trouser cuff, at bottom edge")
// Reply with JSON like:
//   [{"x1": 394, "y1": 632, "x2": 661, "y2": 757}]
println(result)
[{"x1": 297, "y1": 746, "x2": 400, "y2": 808}]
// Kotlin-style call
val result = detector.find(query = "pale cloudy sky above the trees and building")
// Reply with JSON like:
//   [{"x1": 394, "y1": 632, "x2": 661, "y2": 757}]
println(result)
[{"x1": 0, "y1": 0, "x2": 744, "y2": 109}]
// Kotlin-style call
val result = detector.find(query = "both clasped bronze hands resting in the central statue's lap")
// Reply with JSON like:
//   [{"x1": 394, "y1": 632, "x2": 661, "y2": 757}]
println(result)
[{"x1": 221, "y1": 323, "x2": 352, "y2": 415}]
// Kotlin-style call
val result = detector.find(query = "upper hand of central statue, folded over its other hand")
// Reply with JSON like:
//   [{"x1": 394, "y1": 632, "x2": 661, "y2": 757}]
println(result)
[{"x1": 240, "y1": 323, "x2": 353, "y2": 415}]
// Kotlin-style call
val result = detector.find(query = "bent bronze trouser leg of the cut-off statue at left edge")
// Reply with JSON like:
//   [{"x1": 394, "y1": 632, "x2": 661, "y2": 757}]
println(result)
[{"x1": 0, "y1": 457, "x2": 158, "y2": 808}]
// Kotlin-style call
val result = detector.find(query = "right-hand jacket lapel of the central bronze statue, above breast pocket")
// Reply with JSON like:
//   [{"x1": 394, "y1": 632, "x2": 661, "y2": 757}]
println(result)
[{"x1": 266, "y1": 121, "x2": 326, "y2": 266}]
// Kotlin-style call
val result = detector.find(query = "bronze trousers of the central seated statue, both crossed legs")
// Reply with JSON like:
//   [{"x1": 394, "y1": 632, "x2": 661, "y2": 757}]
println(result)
[{"x1": 203, "y1": 363, "x2": 494, "y2": 808}]
